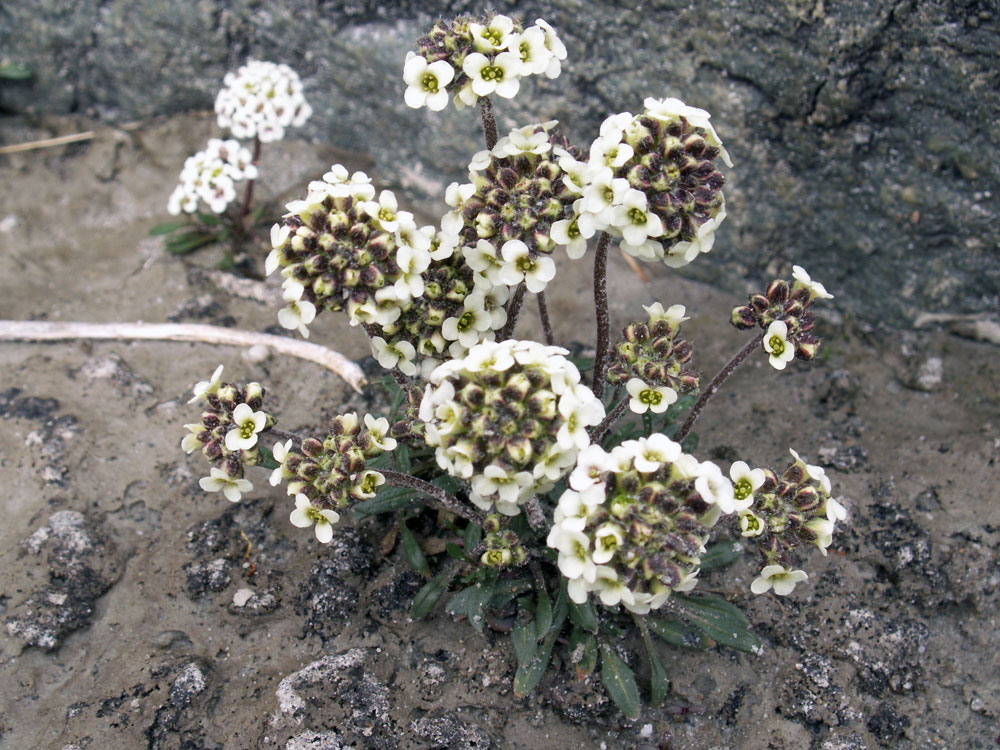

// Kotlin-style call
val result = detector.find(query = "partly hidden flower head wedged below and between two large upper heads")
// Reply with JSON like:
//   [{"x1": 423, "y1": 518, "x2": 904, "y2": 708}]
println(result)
[{"x1": 372, "y1": 233, "x2": 510, "y2": 377}]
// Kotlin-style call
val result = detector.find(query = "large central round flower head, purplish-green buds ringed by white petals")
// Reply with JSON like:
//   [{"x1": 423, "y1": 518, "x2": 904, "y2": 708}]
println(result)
[{"x1": 419, "y1": 340, "x2": 604, "y2": 516}]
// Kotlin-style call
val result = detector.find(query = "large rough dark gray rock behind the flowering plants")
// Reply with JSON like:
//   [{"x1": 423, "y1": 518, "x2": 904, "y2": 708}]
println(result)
[{"x1": 0, "y1": 0, "x2": 1000, "y2": 323}]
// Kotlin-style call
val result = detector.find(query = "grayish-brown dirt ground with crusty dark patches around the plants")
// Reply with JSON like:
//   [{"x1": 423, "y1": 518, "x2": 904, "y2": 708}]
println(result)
[{"x1": 0, "y1": 117, "x2": 1000, "y2": 750}]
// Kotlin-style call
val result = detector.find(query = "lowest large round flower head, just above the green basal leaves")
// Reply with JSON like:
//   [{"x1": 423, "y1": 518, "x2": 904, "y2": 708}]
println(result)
[{"x1": 548, "y1": 434, "x2": 735, "y2": 614}]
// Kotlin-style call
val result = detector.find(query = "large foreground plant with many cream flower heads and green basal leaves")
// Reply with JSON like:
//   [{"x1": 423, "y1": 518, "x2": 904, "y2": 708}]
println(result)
[{"x1": 182, "y1": 10, "x2": 846, "y2": 717}]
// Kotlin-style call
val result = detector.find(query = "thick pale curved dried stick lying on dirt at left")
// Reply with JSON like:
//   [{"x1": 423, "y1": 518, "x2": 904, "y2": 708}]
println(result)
[{"x1": 0, "y1": 320, "x2": 368, "y2": 393}]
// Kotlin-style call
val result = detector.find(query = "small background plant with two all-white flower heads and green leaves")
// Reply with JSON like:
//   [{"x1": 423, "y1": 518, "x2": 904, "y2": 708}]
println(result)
[{"x1": 150, "y1": 60, "x2": 312, "y2": 265}]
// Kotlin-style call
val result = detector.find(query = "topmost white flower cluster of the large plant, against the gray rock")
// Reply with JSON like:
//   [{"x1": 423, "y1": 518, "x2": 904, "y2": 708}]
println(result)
[{"x1": 403, "y1": 15, "x2": 566, "y2": 111}]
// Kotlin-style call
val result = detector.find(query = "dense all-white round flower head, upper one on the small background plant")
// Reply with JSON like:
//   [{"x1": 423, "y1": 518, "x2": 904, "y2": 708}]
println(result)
[{"x1": 215, "y1": 60, "x2": 312, "y2": 143}]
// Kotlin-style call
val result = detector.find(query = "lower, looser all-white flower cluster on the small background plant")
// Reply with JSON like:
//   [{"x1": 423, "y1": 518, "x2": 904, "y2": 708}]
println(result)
[{"x1": 167, "y1": 138, "x2": 257, "y2": 216}]
